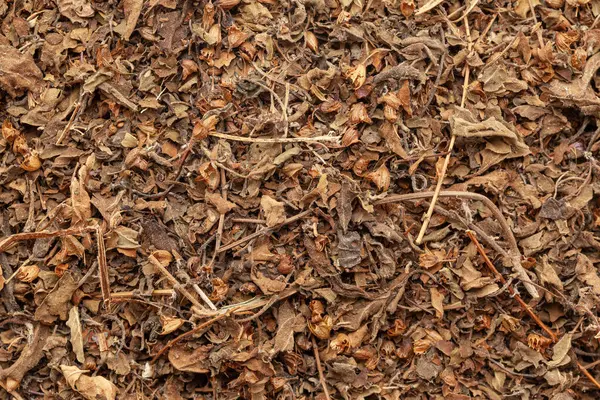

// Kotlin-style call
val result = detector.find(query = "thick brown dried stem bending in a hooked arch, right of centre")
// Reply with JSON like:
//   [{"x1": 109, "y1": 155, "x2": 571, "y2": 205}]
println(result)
[{"x1": 374, "y1": 191, "x2": 540, "y2": 299}]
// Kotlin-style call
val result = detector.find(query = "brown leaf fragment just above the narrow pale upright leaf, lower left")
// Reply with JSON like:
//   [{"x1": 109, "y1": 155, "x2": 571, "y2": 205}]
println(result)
[{"x1": 34, "y1": 271, "x2": 77, "y2": 325}]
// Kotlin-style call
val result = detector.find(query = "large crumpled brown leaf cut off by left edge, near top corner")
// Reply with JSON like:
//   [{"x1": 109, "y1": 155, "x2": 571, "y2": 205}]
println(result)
[{"x1": 0, "y1": 45, "x2": 43, "y2": 97}]
